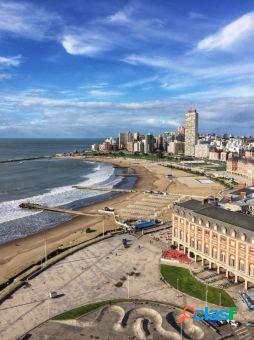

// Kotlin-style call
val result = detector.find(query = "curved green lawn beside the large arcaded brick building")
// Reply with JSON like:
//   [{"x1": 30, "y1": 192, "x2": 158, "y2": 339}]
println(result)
[{"x1": 161, "y1": 265, "x2": 235, "y2": 307}]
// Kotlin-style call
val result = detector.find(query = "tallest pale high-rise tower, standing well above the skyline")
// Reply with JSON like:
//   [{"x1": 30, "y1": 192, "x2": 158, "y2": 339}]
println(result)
[{"x1": 185, "y1": 109, "x2": 198, "y2": 157}]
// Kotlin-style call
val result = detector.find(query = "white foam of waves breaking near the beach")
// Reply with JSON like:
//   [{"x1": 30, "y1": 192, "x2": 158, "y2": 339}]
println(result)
[{"x1": 0, "y1": 164, "x2": 122, "y2": 223}]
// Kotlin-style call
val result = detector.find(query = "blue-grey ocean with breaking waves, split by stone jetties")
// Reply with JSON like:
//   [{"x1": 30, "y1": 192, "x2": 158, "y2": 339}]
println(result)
[{"x1": 0, "y1": 139, "x2": 136, "y2": 243}]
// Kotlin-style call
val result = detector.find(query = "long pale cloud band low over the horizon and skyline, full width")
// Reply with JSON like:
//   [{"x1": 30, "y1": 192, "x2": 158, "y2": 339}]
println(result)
[{"x1": 0, "y1": 93, "x2": 254, "y2": 136}]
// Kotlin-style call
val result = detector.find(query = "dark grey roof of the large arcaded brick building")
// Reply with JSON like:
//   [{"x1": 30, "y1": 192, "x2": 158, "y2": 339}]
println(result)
[{"x1": 176, "y1": 199, "x2": 254, "y2": 231}]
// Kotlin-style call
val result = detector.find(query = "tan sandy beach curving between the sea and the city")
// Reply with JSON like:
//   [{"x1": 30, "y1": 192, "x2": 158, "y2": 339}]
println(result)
[{"x1": 0, "y1": 157, "x2": 223, "y2": 282}]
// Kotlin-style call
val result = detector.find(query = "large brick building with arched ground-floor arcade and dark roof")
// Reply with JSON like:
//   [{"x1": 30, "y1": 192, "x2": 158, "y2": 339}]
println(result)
[{"x1": 172, "y1": 199, "x2": 254, "y2": 289}]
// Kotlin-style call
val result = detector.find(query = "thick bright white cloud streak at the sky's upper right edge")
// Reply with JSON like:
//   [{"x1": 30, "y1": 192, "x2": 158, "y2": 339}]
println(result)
[{"x1": 197, "y1": 12, "x2": 254, "y2": 51}]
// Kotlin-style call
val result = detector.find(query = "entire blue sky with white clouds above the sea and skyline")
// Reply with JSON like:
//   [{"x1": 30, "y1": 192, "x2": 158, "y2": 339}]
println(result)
[{"x1": 0, "y1": 0, "x2": 254, "y2": 137}]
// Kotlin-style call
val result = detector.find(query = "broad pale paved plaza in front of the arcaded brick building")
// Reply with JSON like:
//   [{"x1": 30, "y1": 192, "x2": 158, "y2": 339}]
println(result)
[{"x1": 0, "y1": 235, "x2": 253, "y2": 340}]
